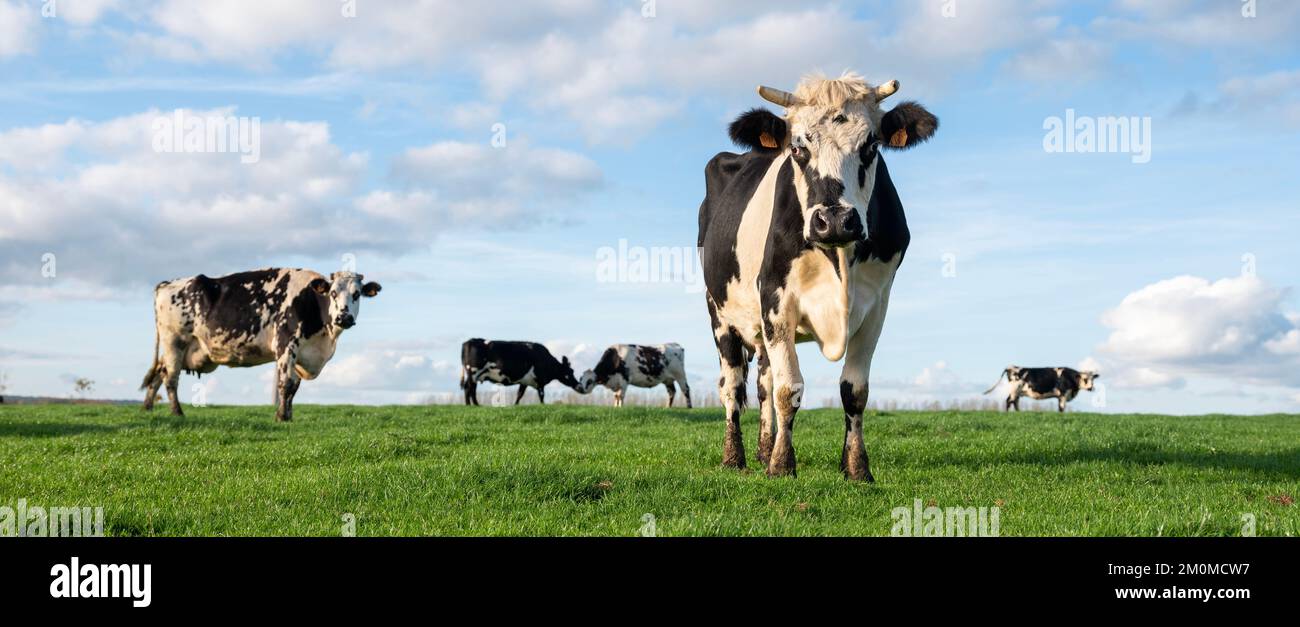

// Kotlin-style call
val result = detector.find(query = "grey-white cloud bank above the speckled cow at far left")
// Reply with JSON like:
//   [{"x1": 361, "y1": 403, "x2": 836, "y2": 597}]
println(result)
[{"x1": 0, "y1": 109, "x2": 601, "y2": 287}]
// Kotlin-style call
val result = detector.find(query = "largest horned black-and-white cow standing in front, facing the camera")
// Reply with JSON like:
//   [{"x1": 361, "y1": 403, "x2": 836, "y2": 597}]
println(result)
[{"x1": 697, "y1": 73, "x2": 939, "y2": 481}]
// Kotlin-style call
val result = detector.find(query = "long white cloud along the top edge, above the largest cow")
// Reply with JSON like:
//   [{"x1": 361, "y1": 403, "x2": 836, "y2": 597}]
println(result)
[{"x1": 7, "y1": 0, "x2": 1104, "y2": 144}]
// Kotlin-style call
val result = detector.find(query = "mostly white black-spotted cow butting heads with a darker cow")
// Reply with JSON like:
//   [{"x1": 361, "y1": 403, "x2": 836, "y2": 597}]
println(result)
[{"x1": 577, "y1": 343, "x2": 690, "y2": 408}]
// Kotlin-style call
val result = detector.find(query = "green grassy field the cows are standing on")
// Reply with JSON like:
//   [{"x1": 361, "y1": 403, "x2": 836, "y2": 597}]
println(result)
[{"x1": 0, "y1": 406, "x2": 1300, "y2": 536}]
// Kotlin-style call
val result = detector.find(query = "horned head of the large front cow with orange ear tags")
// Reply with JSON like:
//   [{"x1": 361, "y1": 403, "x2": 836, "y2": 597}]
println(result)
[{"x1": 731, "y1": 73, "x2": 939, "y2": 248}]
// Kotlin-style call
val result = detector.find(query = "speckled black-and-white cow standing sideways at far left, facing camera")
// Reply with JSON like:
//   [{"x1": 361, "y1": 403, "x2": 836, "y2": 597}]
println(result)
[{"x1": 140, "y1": 268, "x2": 382, "y2": 421}]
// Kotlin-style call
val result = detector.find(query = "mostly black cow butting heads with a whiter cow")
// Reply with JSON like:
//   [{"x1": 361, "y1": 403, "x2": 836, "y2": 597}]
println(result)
[{"x1": 460, "y1": 337, "x2": 579, "y2": 405}]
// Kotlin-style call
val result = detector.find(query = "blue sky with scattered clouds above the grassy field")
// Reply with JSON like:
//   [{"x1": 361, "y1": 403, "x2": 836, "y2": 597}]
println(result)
[{"x1": 0, "y1": 0, "x2": 1300, "y2": 414}]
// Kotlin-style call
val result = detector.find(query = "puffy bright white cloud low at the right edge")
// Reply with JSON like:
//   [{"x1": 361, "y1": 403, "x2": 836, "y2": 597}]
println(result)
[{"x1": 1099, "y1": 276, "x2": 1300, "y2": 388}]
